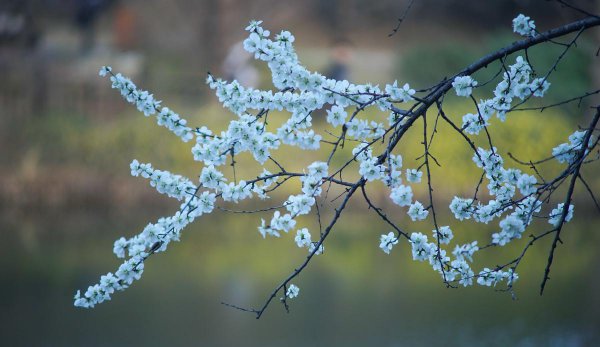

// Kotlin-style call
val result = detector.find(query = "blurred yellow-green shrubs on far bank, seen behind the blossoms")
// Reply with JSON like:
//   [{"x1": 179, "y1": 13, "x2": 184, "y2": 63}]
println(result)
[{"x1": 21, "y1": 97, "x2": 572, "y2": 198}]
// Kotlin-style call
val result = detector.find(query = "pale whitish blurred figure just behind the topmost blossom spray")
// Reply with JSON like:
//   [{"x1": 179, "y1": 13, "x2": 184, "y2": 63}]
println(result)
[{"x1": 223, "y1": 41, "x2": 260, "y2": 88}]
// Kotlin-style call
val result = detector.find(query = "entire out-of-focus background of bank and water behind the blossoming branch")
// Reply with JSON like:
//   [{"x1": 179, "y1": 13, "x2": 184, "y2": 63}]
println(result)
[{"x1": 0, "y1": 0, "x2": 600, "y2": 346}]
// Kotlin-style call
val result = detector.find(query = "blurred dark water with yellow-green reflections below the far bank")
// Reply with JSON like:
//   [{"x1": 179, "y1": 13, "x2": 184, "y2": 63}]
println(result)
[{"x1": 0, "y1": 211, "x2": 600, "y2": 346}]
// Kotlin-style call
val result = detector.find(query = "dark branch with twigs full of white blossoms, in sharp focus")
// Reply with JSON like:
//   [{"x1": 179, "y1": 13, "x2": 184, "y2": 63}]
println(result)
[{"x1": 75, "y1": 9, "x2": 600, "y2": 318}]
